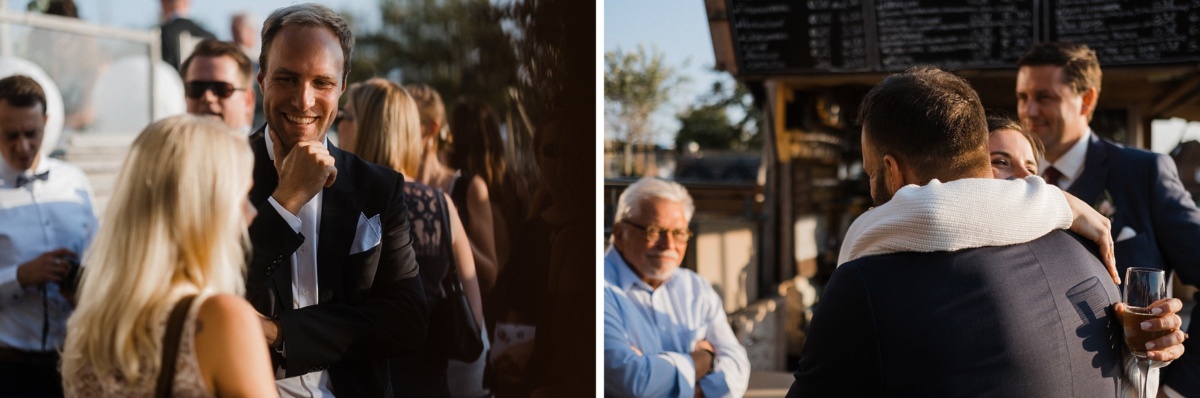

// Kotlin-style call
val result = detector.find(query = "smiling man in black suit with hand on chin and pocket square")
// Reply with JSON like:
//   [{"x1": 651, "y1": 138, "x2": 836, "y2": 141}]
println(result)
[{"x1": 246, "y1": 4, "x2": 427, "y2": 397}]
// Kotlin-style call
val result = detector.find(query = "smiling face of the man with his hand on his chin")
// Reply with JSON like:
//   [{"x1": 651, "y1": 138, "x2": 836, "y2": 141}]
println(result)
[{"x1": 258, "y1": 26, "x2": 344, "y2": 150}]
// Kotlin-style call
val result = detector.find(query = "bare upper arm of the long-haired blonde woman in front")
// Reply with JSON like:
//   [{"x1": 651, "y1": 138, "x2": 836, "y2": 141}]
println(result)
[{"x1": 196, "y1": 294, "x2": 278, "y2": 397}]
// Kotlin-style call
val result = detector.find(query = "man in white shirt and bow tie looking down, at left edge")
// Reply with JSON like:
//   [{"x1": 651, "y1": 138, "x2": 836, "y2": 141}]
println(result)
[{"x1": 0, "y1": 76, "x2": 96, "y2": 397}]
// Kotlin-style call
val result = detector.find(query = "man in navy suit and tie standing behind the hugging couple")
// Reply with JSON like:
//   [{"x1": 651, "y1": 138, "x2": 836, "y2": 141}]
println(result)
[{"x1": 1016, "y1": 43, "x2": 1200, "y2": 396}]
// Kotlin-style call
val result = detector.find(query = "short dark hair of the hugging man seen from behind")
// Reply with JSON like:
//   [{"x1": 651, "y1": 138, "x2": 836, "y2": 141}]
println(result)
[{"x1": 858, "y1": 66, "x2": 989, "y2": 181}]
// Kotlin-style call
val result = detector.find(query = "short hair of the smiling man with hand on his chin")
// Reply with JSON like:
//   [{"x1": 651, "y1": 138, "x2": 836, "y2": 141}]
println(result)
[{"x1": 258, "y1": 2, "x2": 354, "y2": 84}]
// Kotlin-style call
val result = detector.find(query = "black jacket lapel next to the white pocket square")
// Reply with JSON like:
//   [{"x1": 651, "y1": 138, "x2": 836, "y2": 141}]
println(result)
[{"x1": 317, "y1": 145, "x2": 362, "y2": 302}]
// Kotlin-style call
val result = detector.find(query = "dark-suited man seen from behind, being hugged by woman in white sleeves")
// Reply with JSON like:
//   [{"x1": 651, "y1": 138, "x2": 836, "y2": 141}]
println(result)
[{"x1": 788, "y1": 67, "x2": 1182, "y2": 397}]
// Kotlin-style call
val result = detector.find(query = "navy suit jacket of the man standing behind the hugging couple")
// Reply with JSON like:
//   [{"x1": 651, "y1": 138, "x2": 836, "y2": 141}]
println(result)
[{"x1": 1067, "y1": 134, "x2": 1200, "y2": 397}]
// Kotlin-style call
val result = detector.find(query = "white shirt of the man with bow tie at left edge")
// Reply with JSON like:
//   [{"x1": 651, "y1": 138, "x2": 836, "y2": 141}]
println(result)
[{"x1": 0, "y1": 156, "x2": 96, "y2": 352}]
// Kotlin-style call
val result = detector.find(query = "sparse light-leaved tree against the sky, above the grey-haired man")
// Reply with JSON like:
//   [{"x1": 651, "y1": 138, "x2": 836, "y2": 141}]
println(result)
[{"x1": 604, "y1": 46, "x2": 685, "y2": 175}]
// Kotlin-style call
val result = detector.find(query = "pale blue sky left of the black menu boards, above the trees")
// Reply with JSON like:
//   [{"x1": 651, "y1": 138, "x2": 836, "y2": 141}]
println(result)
[{"x1": 601, "y1": 0, "x2": 728, "y2": 147}]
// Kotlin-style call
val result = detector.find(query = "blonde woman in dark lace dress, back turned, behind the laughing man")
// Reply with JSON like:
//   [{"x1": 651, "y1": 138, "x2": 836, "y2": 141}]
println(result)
[{"x1": 337, "y1": 78, "x2": 487, "y2": 397}]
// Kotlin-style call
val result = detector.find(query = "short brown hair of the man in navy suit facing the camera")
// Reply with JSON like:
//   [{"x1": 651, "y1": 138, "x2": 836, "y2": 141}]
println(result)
[{"x1": 1016, "y1": 42, "x2": 1103, "y2": 98}]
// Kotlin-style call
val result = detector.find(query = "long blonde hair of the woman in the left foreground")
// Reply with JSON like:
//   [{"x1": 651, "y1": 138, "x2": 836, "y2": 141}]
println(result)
[{"x1": 62, "y1": 115, "x2": 253, "y2": 384}]
